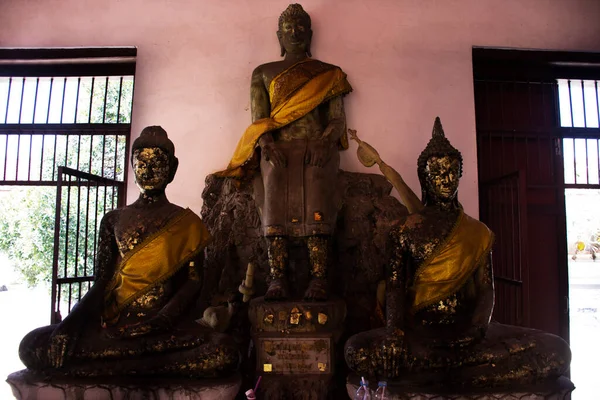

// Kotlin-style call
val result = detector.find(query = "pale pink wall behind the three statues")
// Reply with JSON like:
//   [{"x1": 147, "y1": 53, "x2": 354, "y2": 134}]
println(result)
[{"x1": 0, "y1": 0, "x2": 600, "y2": 215}]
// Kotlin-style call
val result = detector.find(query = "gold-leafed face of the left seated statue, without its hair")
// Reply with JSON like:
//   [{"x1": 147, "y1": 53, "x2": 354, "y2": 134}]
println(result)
[{"x1": 132, "y1": 147, "x2": 170, "y2": 193}]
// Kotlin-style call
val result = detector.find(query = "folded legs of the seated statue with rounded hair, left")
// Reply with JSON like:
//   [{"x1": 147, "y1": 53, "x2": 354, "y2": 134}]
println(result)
[{"x1": 19, "y1": 326, "x2": 240, "y2": 377}]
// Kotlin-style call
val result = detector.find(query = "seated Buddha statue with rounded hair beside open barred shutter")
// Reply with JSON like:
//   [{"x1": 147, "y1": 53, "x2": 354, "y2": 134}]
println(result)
[{"x1": 19, "y1": 126, "x2": 239, "y2": 377}]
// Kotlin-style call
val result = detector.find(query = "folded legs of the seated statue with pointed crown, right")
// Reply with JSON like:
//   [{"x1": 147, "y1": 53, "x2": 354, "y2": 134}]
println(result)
[{"x1": 345, "y1": 323, "x2": 571, "y2": 387}]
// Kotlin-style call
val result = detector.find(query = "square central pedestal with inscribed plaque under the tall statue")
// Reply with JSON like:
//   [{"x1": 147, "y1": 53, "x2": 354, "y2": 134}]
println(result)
[{"x1": 249, "y1": 297, "x2": 346, "y2": 400}]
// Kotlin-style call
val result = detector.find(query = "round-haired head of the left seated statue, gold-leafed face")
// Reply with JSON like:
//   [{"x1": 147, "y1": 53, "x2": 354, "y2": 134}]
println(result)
[{"x1": 131, "y1": 126, "x2": 179, "y2": 193}]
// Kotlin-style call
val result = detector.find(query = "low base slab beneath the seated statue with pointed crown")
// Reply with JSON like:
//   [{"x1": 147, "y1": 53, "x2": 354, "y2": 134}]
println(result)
[{"x1": 346, "y1": 374, "x2": 575, "y2": 400}]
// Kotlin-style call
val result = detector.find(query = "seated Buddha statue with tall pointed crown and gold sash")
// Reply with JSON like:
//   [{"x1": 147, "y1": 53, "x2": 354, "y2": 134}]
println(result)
[{"x1": 345, "y1": 118, "x2": 571, "y2": 388}]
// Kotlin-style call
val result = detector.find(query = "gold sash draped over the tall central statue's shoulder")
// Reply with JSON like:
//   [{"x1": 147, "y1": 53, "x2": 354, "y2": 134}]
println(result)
[{"x1": 216, "y1": 58, "x2": 352, "y2": 178}]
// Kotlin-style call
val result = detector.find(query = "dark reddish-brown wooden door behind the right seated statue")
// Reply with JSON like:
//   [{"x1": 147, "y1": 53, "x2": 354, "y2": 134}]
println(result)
[{"x1": 474, "y1": 50, "x2": 569, "y2": 340}]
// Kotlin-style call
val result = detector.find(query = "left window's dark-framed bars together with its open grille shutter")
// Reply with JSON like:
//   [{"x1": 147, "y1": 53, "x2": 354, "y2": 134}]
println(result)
[{"x1": 0, "y1": 48, "x2": 136, "y2": 323}]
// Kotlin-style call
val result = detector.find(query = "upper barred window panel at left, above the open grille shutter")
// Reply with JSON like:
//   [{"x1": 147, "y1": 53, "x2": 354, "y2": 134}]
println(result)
[{"x1": 0, "y1": 76, "x2": 133, "y2": 185}]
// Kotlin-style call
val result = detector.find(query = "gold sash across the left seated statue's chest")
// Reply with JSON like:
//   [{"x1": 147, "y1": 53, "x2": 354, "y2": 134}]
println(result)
[{"x1": 104, "y1": 208, "x2": 211, "y2": 321}]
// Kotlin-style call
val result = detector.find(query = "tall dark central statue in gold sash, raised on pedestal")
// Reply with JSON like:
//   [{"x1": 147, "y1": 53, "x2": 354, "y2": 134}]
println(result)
[{"x1": 219, "y1": 4, "x2": 352, "y2": 300}]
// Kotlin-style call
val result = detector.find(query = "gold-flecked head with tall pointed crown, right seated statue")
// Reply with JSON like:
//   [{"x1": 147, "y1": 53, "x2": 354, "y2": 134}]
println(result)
[{"x1": 417, "y1": 117, "x2": 462, "y2": 206}]
